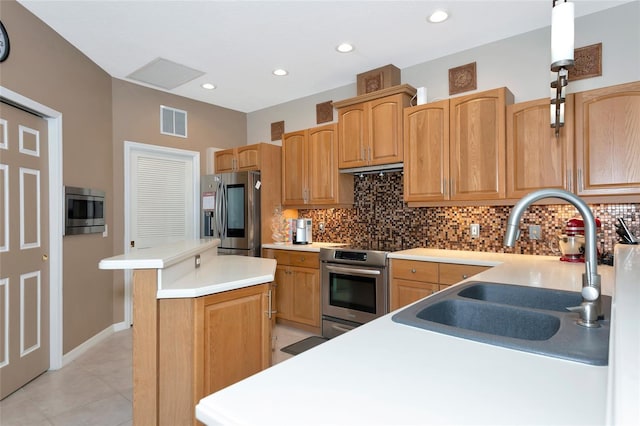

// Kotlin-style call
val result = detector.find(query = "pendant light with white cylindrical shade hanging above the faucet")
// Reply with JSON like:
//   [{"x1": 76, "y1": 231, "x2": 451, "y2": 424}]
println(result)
[{"x1": 550, "y1": 0, "x2": 575, "y2": 137}]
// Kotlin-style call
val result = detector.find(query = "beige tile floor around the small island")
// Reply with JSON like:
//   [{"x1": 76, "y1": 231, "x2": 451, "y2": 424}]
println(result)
[{"x1": 0, "y1": 325, "x2": 312, "y2": 426}]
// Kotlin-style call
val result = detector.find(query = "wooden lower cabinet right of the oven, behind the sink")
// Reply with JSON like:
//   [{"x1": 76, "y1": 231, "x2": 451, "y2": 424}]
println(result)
[{"x1": 389, "y1": 259, "x2": 489, "y2": 311}]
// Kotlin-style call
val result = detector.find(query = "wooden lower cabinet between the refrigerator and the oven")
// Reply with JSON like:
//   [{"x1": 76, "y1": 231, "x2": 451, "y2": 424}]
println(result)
[{"x1": 262, "y1": 249, "x2": 321, "y2": 334}]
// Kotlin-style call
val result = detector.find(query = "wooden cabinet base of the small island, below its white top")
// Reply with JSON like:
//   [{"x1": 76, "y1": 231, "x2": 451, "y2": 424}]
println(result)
[{"x1": 133, "y1": 270, "x2": 272, "y2": 425}]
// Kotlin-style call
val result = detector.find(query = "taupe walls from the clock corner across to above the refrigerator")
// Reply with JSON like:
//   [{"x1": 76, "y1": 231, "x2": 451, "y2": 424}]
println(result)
[{"x1": 0, "y1": 0, "x2": 247, "y2": 354}]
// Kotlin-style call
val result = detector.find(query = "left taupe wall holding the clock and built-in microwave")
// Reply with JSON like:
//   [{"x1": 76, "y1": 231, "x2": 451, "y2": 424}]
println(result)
[{"x1": 0, "y1": 0, "x2": 113, "y2": 353}]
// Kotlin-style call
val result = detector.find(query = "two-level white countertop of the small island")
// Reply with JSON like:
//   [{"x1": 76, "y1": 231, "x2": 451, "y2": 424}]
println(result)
[{"x1": 99, "y1": 238, "x2": 276, "y2": 299}]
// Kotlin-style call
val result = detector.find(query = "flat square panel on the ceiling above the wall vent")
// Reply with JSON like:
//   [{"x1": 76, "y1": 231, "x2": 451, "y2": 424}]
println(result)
[{"x1": 127, "y1": 58, "x2": 204, "y2": 90}]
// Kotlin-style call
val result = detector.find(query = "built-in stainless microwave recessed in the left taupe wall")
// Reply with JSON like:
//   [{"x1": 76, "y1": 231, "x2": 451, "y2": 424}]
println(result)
[{"x1": 64, "y1": 186, "x2": 105, "y2": 235}]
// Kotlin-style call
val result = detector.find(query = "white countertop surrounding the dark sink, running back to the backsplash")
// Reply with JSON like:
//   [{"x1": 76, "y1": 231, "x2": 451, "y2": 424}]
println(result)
[{"x1": 196, "y1": 246, "x2": 640, "y2": 425}]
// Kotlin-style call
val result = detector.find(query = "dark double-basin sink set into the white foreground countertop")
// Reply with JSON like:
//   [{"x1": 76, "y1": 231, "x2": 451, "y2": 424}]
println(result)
[{"x1": 392, "y1": 281, "x2": 611, "y2": 365}]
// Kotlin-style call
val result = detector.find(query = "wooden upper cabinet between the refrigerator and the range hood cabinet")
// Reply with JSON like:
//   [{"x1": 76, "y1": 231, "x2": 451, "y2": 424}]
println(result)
[{"x1": 282, "y1": 123, "x2": 353, "y2": 208}]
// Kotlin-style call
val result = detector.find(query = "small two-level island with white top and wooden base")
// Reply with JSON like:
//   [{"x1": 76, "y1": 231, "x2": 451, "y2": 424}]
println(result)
[{"x1": 99, "y1": 239, "x2": 276, "y2": 425}]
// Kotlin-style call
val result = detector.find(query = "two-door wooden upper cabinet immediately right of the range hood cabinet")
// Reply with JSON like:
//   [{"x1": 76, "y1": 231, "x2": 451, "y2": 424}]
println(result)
[{"x1": 404, "y1": 87, "x2": 513, "y2": 202}]
